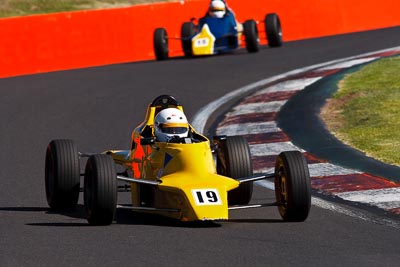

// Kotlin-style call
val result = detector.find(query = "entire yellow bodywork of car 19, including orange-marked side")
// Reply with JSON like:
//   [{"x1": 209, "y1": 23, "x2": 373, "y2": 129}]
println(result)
[{"x1": 106, "y1": 102, "x2": 239, "y2": 221}]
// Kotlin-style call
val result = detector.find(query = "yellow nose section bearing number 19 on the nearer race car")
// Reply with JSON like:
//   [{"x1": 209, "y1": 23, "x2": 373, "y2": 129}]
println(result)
[{"x1": 146, "y1": 142, "x2": 239, "y2": 221}]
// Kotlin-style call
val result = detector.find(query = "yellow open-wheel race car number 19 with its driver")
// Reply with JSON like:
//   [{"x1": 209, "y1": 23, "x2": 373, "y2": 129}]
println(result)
[{"x1": 45, "y1": 95, "x2": 311, "y2": 225}]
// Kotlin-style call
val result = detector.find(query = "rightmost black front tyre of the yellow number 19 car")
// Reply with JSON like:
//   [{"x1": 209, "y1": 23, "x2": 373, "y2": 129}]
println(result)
[{"x1": 275, "y1": 151, "x2": 311, "y2": 222}]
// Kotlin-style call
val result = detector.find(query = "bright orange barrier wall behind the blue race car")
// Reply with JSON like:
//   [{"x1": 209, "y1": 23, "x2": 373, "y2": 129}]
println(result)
[{"x1": 0, "y1": 0, "x2": 400, "y2": 78}]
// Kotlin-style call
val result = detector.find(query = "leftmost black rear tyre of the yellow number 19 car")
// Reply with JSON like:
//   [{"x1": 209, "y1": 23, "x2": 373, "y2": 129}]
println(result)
[{"x1": 45, "y1": 139, "x2": 80, "y2": 210}]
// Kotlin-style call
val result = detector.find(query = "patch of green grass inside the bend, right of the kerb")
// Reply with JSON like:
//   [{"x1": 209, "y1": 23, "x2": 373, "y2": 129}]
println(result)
[{"x1": 323, "y1": 57, "x2": 400, "y2": 166}]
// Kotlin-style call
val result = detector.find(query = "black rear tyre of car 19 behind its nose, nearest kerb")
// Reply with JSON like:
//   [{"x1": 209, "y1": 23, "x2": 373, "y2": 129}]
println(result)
[{"x1": 217, "y1": 136, "x2": 253, "y2": 205}]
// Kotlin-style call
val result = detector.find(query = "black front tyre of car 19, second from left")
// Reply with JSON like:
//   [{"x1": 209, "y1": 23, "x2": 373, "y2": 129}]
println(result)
[{"x1": 84, "y1": 154, "x2": 117, "y2": 225}]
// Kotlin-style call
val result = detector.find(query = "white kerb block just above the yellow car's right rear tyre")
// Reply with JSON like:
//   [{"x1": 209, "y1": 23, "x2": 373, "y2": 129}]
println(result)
[{"x1": 217, "y1": 121, "x2": 281, "y2": 135}]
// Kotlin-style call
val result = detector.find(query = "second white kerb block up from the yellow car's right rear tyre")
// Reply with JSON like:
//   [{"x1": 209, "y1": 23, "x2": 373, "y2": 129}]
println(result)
[{"x1": 227, "y1": 100, "x2": 287, "y2": 116}]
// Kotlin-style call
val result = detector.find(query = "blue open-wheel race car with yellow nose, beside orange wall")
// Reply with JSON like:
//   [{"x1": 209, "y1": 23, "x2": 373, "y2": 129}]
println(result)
[{"x1": 153, "y1": 1, "x2": 283, "y2": 60}]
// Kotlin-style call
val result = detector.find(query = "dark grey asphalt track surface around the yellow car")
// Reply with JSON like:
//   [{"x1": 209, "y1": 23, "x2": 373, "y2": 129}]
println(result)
[{"x1": 0, "y1": 27, "x2": 400, "y2": 266}]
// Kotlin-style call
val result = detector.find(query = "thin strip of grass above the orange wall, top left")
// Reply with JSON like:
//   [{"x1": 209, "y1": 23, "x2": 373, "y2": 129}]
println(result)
[{"x1": 0, "y1": 0, "x2": 176, "y2": 18}]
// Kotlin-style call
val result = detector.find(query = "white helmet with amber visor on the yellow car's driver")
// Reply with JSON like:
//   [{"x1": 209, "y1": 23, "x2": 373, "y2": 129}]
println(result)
[{"x1": 154, "y1": 108, "x2": 189, "y2": 142}]
